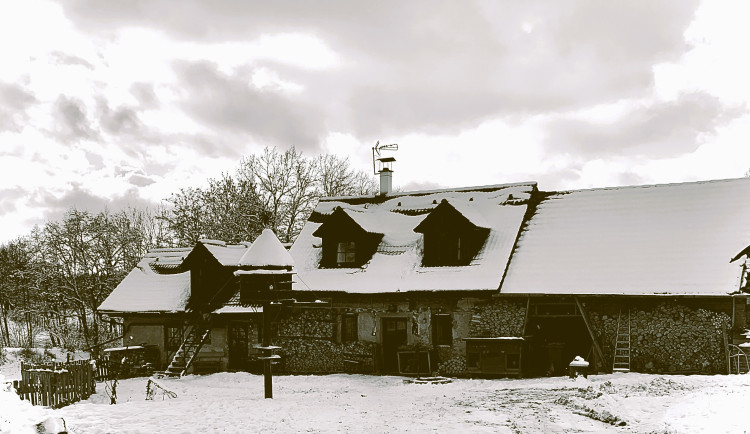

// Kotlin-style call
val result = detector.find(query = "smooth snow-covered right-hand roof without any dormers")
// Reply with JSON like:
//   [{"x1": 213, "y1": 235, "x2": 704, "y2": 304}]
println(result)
[{"x1": 501, "y1": 178, "x2": 750, "y2": 295}]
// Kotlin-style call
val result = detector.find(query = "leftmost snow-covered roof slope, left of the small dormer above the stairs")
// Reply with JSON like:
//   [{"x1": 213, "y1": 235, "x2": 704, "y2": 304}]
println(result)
[{"x1": 99, "y1": 249, "x2": 190, "y2": 312}]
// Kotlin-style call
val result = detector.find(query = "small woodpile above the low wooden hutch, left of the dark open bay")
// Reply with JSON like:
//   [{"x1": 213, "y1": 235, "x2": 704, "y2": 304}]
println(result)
[{"x1": 470, "y1": 300, "x2": 526, "y2": 337}]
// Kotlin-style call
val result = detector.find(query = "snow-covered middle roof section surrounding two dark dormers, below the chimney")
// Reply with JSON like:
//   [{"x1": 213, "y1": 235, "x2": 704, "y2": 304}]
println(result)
[{"x1": 290, "y1": 182, "x2": 536, "y2": 293}]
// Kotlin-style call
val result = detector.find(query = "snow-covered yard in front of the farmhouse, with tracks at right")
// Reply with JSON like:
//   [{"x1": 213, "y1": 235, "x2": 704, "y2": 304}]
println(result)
[{"x1": 0, "y1": 350, "x2": 750, "y2": 434}]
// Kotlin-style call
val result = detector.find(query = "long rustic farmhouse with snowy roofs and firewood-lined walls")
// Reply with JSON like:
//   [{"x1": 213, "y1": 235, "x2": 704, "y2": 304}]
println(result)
[{"x1": 100, "y1": 175, "x2": 750, "y2": 376}]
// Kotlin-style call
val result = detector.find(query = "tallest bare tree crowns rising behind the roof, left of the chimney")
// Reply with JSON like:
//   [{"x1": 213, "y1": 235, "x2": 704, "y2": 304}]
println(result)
[{"x1": 164, "y1": 147, "x2": 377, "y2": 245}]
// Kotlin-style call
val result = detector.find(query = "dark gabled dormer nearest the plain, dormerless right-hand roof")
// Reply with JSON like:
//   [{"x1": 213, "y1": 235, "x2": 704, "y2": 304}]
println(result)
[{"x1": 414, "y1": 199, "x2": 490, "y2": 267}]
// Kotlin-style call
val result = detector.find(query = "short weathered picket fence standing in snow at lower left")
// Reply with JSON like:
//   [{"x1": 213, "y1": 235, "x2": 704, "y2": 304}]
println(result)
[{"x1": 13, "y1": 360, "x2": 96, "y2": 408}]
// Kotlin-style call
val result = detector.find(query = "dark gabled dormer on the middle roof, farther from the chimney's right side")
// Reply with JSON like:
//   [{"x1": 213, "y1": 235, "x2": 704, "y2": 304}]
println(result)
[{"x1": 313, "y1": 207, "x2": 383, "y2": 268}]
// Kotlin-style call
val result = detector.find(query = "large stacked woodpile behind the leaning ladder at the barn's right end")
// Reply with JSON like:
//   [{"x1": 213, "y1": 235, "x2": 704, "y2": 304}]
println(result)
[{"x1": 592, "y1": 303, "x2": 729, "y2": 373}]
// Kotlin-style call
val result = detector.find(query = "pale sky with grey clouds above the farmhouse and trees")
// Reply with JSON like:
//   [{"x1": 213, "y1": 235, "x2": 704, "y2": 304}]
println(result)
[{"x1": 0, "y1": 0, "x2": 750, "y2": 242}]
